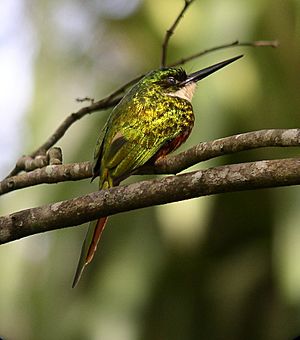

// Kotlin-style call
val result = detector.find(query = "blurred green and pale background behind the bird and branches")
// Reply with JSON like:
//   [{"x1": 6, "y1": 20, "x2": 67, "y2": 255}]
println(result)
[{"x1": 0, "y1": 0, "x2": 300, "y2": 340}]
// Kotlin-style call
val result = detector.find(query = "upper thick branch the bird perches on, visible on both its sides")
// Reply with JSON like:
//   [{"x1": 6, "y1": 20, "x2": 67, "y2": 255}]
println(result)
[{"x1": 0, "y1": 129, "x2": 300, "y2": 195}]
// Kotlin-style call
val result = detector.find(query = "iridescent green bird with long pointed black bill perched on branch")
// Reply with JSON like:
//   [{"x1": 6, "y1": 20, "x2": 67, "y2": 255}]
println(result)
[{"x1": 73, "y1": 56, "x2": 242, "y2": 287}]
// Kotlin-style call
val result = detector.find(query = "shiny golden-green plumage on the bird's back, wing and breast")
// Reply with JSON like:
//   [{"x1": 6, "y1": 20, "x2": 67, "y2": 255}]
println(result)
[{"x1": 97, "y1": 69, "x2": 194, "y2": 182}]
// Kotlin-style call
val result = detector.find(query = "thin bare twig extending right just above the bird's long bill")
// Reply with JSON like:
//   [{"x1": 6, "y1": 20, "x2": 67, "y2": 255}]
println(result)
[{"x1": 168, "y1": 40, "x2": 279, "y2": 67}]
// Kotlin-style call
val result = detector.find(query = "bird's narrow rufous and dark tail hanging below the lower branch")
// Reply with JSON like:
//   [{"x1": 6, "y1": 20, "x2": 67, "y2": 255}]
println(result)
[{"x1": 72, "y1": 217, "x2": 107, "y2": 288}]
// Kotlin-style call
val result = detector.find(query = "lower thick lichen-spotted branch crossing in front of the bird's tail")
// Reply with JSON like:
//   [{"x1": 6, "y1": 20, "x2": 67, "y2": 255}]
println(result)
[{"x1": 0, "y1": 158, "x2": 300, "y2": 244}]
